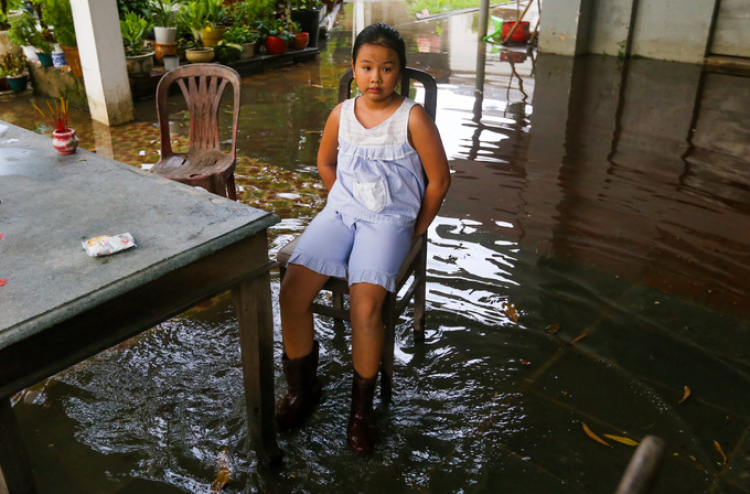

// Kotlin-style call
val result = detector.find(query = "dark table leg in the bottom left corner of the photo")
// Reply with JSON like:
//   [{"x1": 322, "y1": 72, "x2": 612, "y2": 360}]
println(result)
[{"x1": 0, "y1": 398, "x2": 36, "y2": 494}]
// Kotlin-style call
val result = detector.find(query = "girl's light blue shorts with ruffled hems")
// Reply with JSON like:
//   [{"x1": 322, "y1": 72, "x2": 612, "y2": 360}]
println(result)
[{"x1": 289, "y1": 207, "x2": 414, "y2": 292}]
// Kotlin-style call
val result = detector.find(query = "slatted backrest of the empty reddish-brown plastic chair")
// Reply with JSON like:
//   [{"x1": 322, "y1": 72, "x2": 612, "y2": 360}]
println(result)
[{"x1": 156, "y1": 63, "x2": 240, "y2": 158}]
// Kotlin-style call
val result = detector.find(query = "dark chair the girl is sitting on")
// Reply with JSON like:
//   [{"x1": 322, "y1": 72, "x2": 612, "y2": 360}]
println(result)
[{"x1": 276, "y1": 67, "x2": 437, "y2": 401}]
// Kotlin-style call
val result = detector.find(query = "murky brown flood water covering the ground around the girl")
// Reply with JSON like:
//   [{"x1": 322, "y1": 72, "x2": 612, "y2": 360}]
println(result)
[{"x1": 0, "y1": 2, "x2": 750, "y2": 494}]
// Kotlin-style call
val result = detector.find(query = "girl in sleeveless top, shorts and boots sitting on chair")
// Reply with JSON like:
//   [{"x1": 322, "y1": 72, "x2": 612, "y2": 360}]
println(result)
[{"x1": 276, "y1": 23, "x2": 450, "y2": 452}]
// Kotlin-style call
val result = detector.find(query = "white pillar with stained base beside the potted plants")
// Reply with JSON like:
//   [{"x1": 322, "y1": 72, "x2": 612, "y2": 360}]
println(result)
[{"x1": 70, "y1": 0, "x2": 133, "y2": 126}]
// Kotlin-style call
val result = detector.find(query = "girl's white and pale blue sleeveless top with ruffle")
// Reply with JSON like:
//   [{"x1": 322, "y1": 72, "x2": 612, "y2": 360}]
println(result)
[{"x1": 328, "y1": 98, "x2": 425, "y2": 226}]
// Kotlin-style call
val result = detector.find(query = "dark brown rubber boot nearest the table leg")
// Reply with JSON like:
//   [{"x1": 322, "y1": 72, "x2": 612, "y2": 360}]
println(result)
[{"x1": 274, "y1": 341, "x2": 322, "y2": 432}]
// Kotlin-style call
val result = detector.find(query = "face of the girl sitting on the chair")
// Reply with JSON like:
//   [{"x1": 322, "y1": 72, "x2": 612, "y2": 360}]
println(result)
[{"x1": 352, "y1": 44, "x2": 400, "y2": 101}]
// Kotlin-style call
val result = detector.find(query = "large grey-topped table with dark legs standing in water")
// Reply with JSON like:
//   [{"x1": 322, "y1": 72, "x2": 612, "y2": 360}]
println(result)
[{"x1": 0, "y1": 121, "x2": 280, "y2": 494}]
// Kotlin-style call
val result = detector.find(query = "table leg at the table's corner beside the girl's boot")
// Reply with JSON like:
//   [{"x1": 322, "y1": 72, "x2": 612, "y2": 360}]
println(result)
[{"x1": 232, "y1": 272, "x2": 281, "y2": 468}]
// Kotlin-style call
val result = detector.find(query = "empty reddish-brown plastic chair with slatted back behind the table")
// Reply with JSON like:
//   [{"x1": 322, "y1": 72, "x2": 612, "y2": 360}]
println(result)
[{"x1": 151, "y1": 63, "x2": 240, "y2": 200}]
